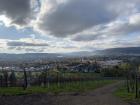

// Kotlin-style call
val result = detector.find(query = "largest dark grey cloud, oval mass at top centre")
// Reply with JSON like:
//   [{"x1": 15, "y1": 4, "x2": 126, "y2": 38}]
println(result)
[{"x1": 39, "y1": 0, "x2": 118, "y2": 37}]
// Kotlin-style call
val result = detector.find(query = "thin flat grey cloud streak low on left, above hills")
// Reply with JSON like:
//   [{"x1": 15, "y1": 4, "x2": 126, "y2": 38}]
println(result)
[{"x1": 7, "y1": 41, "x2": 49, "y2": 47}]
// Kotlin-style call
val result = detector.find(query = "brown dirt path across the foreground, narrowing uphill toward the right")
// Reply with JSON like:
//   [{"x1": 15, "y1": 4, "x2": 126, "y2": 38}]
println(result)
[{"x1": 0, "y1": 83, "x2": 134, "y2": 105}]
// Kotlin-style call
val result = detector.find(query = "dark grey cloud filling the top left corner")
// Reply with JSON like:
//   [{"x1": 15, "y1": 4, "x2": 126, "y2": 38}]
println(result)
[{"x1": 0, "y1": 0, "x2": 32, "y2": 25}]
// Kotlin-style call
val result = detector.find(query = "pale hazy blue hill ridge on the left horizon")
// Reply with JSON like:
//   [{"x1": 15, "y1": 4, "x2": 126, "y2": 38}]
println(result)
[{"x1": 0, "y1": 51, "x2": 93, "y2": 62}]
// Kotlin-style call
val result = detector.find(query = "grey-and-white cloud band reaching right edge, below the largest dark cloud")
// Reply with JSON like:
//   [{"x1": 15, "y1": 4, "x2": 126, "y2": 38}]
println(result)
[{"x1": 71, "y1": 14, "x2": 140, "y2": 41}]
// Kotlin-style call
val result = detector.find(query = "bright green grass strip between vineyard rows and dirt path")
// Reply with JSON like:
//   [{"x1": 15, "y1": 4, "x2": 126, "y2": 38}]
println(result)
[{"x1": 0, "y1": 80, "x2": 117, "y2": 95}]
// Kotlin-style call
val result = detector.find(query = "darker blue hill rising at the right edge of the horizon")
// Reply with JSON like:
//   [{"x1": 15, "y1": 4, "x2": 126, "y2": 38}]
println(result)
[{"x1": 95, "y1": 47, "x2": 140, "y2": 55}]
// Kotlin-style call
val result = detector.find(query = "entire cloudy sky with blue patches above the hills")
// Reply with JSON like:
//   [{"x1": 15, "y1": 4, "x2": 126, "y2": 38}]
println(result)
[{"x1": 0, "y1": 0, "x2": 140, "y2": 53}]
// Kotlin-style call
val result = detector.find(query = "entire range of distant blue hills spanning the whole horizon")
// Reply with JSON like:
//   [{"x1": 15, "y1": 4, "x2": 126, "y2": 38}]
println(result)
[{"x1": 0, "y1": 47, "x2": 140, "y2": 61}]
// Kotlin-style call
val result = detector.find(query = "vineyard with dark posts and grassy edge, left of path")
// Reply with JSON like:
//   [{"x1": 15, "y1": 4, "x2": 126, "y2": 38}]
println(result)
[{"x1": 0, "y1": 64, "x2": 120, "y2": 95}]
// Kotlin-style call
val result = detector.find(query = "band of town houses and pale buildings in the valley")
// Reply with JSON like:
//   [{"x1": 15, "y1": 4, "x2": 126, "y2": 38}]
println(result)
[{"x1": 0, "y1": 60, "x2": 123, "y2": 72}]
